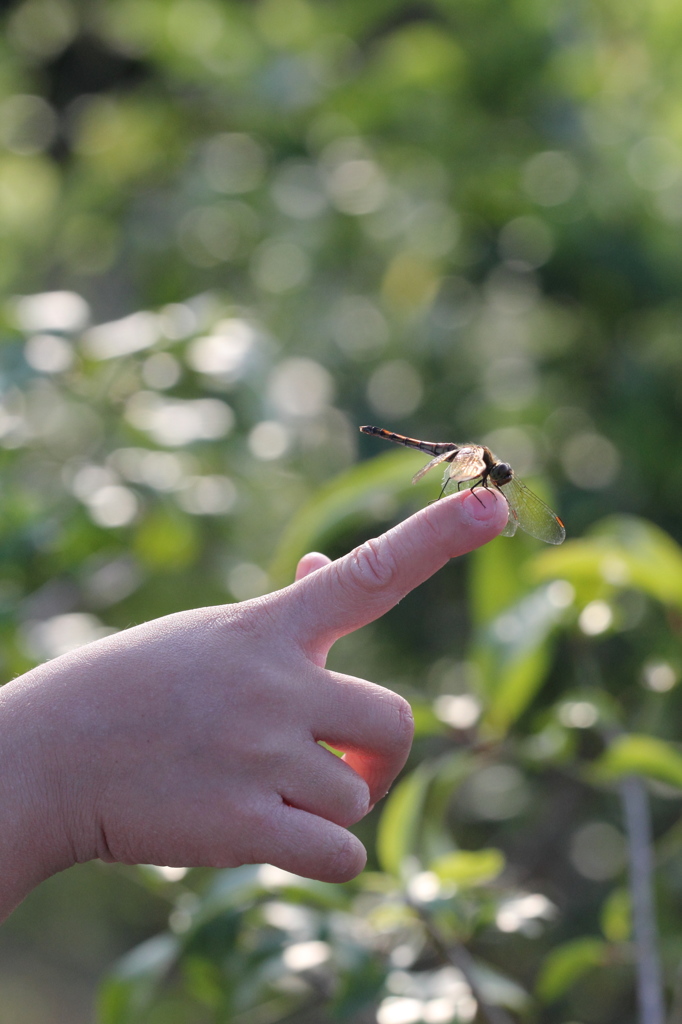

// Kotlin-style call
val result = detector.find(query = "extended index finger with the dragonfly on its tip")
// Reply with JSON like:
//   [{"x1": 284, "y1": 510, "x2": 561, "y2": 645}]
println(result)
[{"x1": 280, "y1": 488, "x2": 508, "y2": 654}]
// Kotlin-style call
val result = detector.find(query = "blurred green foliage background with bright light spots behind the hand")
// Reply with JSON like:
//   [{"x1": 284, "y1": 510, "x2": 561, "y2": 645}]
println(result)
[{"x1": 0, "y1": 0, "x2": 682, "y2": 1024}]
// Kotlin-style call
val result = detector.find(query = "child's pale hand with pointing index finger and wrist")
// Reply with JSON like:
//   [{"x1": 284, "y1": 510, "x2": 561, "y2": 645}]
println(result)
[{"x1": 0, "y1": 489, "x2": 507, "y2": 920}]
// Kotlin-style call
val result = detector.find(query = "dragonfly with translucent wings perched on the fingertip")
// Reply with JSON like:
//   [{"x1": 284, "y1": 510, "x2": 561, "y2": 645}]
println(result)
[{"x1": 360, "y1": 426, "x2": 566, "y2": 544}]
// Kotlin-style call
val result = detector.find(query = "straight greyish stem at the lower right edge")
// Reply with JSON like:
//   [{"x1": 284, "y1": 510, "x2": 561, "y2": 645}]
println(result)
[{"x1": 621, "y1": 775, "x2": 666, "y2": 1024}]
